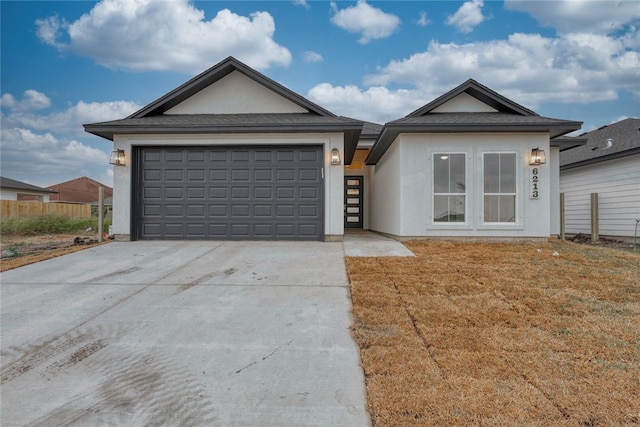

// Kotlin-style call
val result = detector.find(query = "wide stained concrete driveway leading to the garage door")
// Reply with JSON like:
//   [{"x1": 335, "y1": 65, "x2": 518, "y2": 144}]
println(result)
[{"x1": 0, "y1": 241, "x2": 370, "y2": 427}]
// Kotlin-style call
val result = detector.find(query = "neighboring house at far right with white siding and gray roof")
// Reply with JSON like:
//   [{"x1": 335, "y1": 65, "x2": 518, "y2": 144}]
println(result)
[{"x1": 560, "y1": 118, "x2": 640, "y2": 237}]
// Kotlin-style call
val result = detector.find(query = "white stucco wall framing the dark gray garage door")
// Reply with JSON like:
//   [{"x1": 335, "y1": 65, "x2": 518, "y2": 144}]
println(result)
[{"x1": 113, "y1": 133, "x2": 344, "y2": 240}]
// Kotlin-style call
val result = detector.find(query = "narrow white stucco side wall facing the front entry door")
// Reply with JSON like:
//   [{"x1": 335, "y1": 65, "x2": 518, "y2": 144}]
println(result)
[{"x1": 369, "y1": 140, "x2": 402, "y2": 236}]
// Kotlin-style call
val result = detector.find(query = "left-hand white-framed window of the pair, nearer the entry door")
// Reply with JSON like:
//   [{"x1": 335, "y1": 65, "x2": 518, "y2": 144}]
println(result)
[{"x1": 433, "y1": 153, "x2": 467, "y2": 224}]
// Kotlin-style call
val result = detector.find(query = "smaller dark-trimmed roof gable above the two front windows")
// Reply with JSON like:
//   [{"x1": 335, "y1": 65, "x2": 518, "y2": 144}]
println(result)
[{"x1": 407, "y1": 79, "x2": 537, "y2": 117}]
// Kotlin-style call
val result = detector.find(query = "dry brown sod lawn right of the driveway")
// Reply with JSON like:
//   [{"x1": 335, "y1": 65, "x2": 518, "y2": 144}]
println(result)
[{"x1": 347, "y1": 241, "x2": 640, "y2": 426}]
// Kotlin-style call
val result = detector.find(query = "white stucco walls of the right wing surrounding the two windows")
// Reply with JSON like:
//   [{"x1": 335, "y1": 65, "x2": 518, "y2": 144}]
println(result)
[{"x1": 371, "y1": 133, "x2": 559, "y2": 238}]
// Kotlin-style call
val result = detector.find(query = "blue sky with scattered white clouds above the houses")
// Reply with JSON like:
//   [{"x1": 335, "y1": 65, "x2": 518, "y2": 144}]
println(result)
[{"x1": 0, "y1": 0, "x2": 640, "y2": 186}]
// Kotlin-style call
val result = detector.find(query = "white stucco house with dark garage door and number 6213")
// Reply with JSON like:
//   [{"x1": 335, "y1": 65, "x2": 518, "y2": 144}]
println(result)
[{"x1": 85, "y1": 58, "x2": 581, "y2": 240}]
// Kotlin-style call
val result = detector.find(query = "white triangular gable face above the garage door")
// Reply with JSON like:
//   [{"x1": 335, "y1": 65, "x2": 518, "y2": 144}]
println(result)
[{"x1": 165, "y1": 71, "x2": 309, "y2": 114}]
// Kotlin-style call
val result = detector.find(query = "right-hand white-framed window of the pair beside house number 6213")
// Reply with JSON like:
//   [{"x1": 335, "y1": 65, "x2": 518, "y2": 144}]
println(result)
[{"x1": 482, "y1": 153, "x2": 518, "y2": 224}]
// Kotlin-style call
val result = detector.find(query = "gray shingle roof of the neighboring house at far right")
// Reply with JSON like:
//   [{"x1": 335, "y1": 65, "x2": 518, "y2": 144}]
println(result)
[{"x1": 560, "y1": 118, "x2": 640, "y2": 169}]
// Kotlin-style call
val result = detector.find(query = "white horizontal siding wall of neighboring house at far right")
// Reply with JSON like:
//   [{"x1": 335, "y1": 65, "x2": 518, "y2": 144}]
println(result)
[{"x1": 560, "y1": 154, "x2": 640, "y2": 237}]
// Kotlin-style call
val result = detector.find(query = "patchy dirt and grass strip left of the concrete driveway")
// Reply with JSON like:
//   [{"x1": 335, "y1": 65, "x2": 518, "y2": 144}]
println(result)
[{"x1": 0, "y1": 233, "x2": 109, "y2": 271}]
